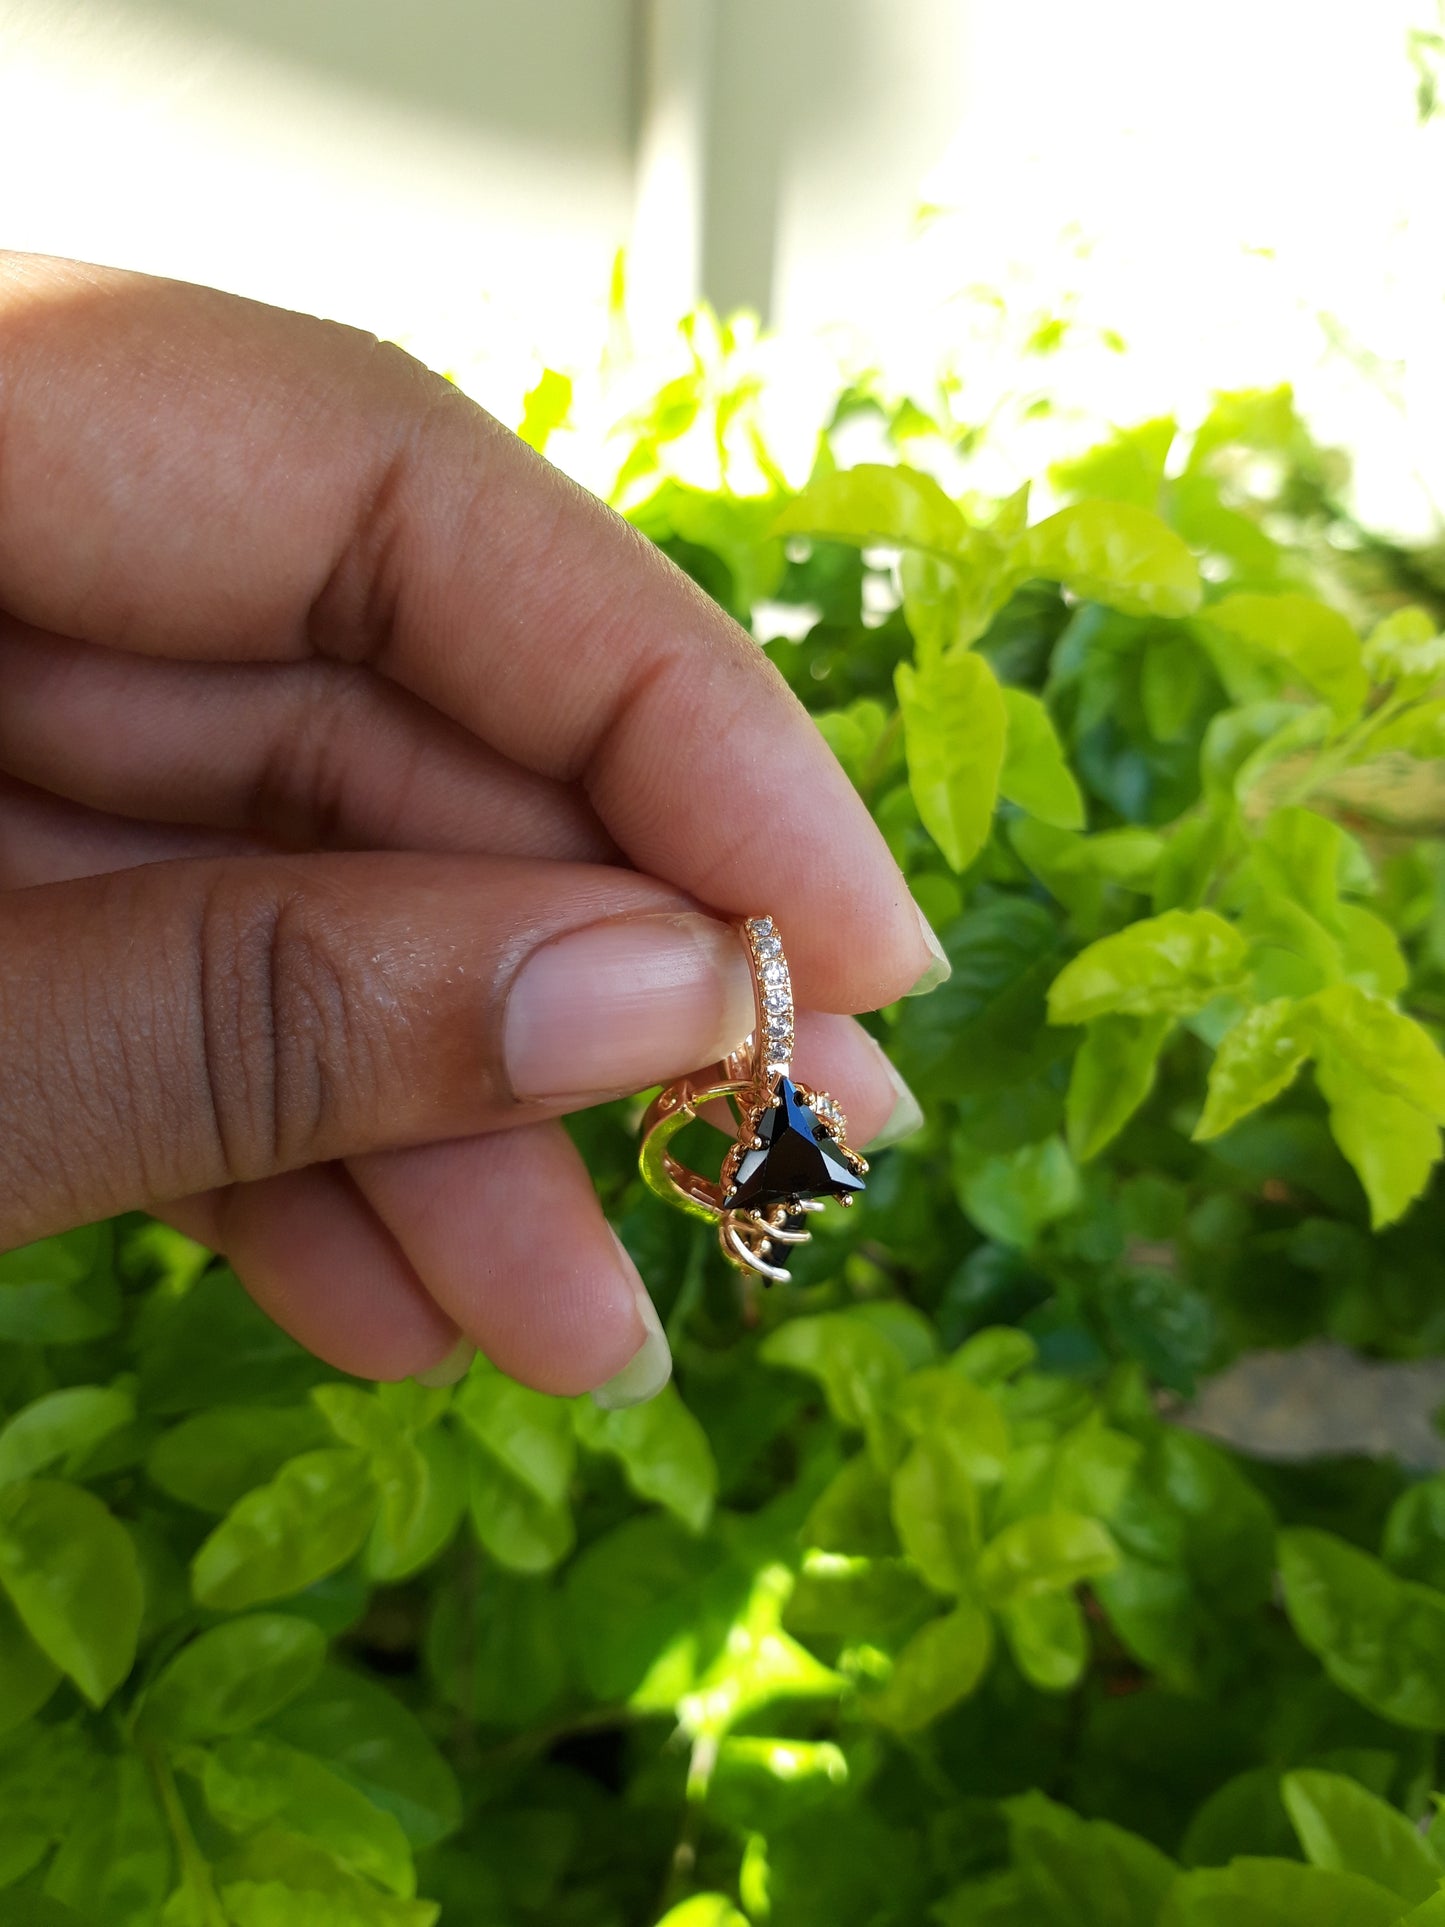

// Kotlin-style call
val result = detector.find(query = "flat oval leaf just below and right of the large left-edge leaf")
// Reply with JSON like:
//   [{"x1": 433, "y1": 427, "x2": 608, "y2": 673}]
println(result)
[{"x1": 139, "y1": 1613, "x2": 326, "y2": 1742}]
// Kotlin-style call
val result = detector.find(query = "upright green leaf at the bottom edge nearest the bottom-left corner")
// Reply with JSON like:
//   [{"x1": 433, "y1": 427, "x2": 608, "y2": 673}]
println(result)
[{"x1": 44, "y1": 1755, "x2": 171, "y2": 1927}]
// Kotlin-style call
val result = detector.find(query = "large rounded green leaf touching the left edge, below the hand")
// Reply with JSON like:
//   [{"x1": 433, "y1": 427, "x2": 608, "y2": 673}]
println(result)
[{"x1": 0, "y1": 1478, "x2": 143, "y2": 1705}]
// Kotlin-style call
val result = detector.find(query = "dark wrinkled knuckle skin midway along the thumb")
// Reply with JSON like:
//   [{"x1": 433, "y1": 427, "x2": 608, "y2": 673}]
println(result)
[{"x1": 200, "y1": 877, "x2": 385, "y2": 1179}]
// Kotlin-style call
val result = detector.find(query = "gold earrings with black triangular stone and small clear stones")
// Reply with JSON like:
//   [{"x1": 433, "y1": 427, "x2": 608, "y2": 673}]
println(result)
[{"x1": 640, "y1": 917, "x2": 867, "y2": 1283}]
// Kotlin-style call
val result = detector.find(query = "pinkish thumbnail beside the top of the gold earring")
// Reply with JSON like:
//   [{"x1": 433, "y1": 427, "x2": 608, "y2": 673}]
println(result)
[{"x1": 503, "y1": 911, "x2": 753, "y2": 1098}]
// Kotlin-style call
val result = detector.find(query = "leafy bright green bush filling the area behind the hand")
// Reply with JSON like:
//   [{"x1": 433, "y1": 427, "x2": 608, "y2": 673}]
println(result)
[{"x1": 0, "y1": 316, "x2": 1445, "y2": 1927}]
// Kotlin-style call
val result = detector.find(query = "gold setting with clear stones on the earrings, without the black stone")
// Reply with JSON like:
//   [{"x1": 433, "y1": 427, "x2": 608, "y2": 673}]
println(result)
[{"x1": 640, "y1": 917, "x2": 867, "y2": 1283}]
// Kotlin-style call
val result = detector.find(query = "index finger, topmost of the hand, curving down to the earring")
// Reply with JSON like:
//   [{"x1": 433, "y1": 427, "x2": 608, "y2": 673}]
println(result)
[{"x1": 0, "y1": 256, "x2": 933, "y2": 1010}]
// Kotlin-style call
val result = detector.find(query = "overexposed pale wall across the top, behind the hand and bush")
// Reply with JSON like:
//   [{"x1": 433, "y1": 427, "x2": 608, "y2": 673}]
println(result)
[{"x1": 0, "y1": 0, "x2": 1445, "y2": 540}]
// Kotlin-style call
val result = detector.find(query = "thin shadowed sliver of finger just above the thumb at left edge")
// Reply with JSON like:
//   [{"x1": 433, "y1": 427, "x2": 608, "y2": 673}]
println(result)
[{"x1": 0, "y1": 777, "x2": 264, "y2": 890}]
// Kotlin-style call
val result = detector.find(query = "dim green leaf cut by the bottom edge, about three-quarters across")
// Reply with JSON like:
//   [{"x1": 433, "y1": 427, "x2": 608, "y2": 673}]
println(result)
[{"x1": 1006, "y1": 1792, "x2": 1177, "y2": 1927}]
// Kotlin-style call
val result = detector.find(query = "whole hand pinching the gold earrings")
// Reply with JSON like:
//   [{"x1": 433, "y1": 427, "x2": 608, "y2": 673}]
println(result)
[{"x1": 0, "y1": 254, "x2": 934, "y2": 1395}]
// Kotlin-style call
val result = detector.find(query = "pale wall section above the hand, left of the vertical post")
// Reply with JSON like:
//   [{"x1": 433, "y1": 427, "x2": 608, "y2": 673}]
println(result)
[{"x1": 0, "y1": 0, "x2": 634, "y2": 358}]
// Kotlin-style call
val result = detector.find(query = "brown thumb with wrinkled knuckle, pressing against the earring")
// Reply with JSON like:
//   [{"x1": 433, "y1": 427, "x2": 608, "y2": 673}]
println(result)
[{"x1": 0, "y1": 854, "x2": 753, "y2": 1249}]
